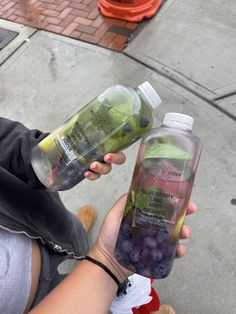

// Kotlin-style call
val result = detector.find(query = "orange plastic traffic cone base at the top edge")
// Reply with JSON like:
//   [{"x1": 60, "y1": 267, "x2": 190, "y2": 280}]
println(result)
[{"x1": 98, "y1": 0, "x2": 162, "y2": 22}]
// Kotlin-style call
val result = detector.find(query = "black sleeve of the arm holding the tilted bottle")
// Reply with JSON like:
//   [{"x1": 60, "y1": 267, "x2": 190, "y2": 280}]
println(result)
[{"x1": 0, "y1": 117, "x2": 48, "y2": 188}]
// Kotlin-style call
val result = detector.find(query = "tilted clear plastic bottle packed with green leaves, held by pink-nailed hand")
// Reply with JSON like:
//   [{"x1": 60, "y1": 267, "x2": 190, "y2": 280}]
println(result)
[{"x1": 31, "y1": 82, "x2": 161, "y2": 191}]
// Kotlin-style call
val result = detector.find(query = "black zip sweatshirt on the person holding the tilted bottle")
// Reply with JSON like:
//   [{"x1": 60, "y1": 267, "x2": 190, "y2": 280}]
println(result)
[{"x1": 0, "y1": 118, "x2": 88, "y2": 257}]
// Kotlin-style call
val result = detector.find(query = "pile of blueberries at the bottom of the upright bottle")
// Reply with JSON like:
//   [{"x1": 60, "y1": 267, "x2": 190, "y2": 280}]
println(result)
[{"x1": 115, "y1": 210, "x2": 177, "y2": 278}]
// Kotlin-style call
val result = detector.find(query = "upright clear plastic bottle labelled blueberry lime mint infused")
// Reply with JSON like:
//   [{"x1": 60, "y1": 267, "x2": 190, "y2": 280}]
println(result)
[{"x1": 115, "y1": 113, "x2": 202, "y2": 279}]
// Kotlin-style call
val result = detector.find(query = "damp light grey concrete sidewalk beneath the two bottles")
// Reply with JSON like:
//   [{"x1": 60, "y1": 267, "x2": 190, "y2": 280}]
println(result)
[{"x1": 0, "y1": 0, "x2": 236, "y2": 314}]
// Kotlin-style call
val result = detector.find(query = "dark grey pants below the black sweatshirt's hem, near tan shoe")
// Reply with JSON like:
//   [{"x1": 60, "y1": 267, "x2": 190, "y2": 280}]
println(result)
[{"x1": 31, "y1": 214, "x2": 88, "y2": 309}]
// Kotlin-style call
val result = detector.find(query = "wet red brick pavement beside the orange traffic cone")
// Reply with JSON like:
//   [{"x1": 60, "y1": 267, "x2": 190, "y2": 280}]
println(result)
[{"x1": 0, "y1": 0, "x2": 145, "y2": 51}]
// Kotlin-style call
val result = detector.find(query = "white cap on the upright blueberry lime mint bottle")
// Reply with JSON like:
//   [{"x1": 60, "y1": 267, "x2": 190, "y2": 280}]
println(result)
[{"x1": 163, "y1": 112, "x2": 193, "y2": 130}]
